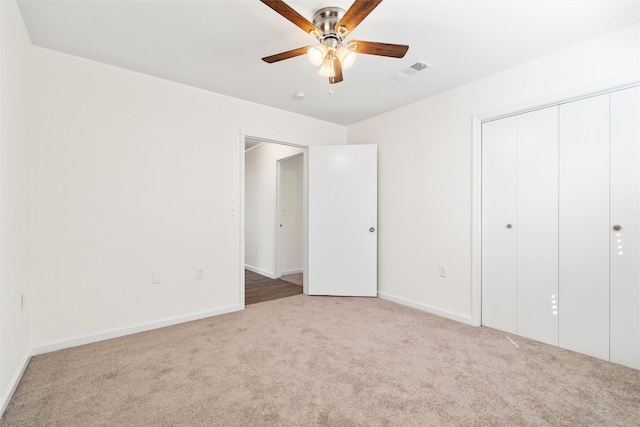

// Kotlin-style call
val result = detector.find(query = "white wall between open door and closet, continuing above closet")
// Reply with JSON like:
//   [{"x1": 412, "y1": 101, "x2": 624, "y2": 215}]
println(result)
[{"x1": 347, "y1": 25, "x2": 640, "y2": 321}]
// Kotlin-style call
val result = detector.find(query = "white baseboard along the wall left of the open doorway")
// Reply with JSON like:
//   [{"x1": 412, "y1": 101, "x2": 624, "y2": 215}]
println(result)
[{"x1": 31, "y1": 305, "x2": 243, "y2": 356}]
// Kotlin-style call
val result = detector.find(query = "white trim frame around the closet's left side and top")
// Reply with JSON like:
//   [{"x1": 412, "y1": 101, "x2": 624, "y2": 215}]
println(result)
[{"x1": 471, "y1": 73, "x2": 640, "y2": 326}]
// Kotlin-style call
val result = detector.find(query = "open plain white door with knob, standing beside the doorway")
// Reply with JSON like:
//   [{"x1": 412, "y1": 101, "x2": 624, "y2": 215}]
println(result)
[{"x1": 307, "y1": 145, "x2": 378, "y2": 297}]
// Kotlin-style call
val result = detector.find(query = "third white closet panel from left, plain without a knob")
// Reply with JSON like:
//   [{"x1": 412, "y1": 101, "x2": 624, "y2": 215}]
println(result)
[{"x1": 559, "y1": 94, "x2": 610, "y2": 360}]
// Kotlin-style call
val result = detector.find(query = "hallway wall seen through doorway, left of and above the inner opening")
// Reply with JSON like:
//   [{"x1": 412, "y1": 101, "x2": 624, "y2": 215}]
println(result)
[{"x1": 245, "y1": 144, "x2": 303, "y2": 278}]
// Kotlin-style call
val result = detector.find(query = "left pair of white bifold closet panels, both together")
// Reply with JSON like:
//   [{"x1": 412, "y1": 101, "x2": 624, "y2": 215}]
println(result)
[{"x1": 482, "y1": 106, "x2": 558, "y2": 345}]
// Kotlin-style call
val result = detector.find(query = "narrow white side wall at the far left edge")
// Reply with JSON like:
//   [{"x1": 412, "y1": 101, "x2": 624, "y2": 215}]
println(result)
[{"x1": 0, "y1": 0, "x2": 32, "y2": 415}]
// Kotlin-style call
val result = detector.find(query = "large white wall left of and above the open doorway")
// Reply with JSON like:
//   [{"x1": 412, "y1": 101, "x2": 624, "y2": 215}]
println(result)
[{"x1": 30, "y1": 47, "x2": 346, "y2": 345}]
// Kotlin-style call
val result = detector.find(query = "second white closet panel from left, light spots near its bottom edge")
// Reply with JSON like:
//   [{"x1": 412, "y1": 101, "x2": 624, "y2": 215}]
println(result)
[{"x1": 516, "y1": 106, "x2": 558, "y2": 346}]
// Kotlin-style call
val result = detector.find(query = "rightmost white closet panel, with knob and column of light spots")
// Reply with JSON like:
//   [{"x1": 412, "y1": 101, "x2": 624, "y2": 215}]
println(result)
[{"x1": 609, "y1": 87, "x2": 640, "y2": 369}]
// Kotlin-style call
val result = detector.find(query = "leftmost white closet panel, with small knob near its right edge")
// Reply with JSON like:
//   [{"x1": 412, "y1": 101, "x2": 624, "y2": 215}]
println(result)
[{"x1": 482, "y1": 117, "x2": 517, "y2": 334}]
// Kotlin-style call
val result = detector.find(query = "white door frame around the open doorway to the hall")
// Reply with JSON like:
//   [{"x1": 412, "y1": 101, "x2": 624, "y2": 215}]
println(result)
[{"x1": 238, "y1": 130, "x2": 309, "y2": 310}]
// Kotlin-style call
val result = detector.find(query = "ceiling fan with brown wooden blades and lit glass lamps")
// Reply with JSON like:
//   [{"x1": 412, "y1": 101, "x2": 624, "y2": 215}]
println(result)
[{"x1": 260, "y1": 0, "x2": 409, "y2": 84}]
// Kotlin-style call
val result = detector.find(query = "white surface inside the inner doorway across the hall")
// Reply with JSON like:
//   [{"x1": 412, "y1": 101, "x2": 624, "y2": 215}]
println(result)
[{"x1": 278, "y1": 155, "x2": 304, "y2": 275}]
